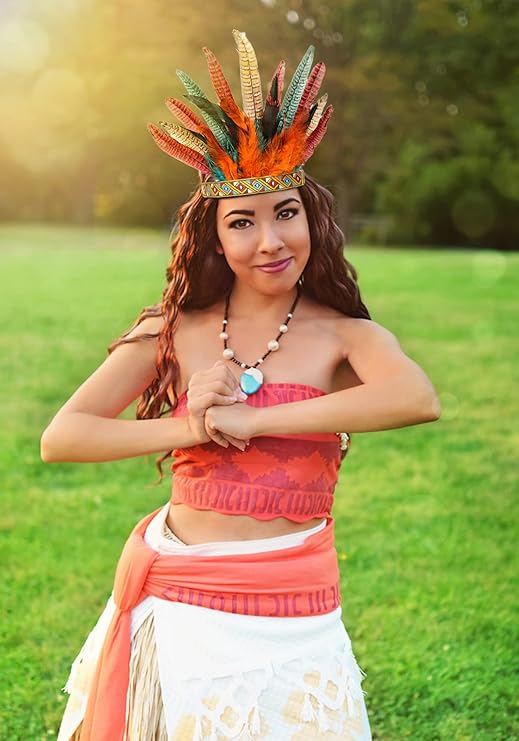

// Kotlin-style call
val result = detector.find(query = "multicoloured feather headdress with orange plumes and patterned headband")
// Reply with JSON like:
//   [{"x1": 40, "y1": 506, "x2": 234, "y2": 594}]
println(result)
[{"x1": 148, "y1": 30, "x2": 333, "y2": 198}]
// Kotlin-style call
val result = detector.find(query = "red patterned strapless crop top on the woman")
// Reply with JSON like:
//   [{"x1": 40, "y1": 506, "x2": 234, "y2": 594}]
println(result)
[{"x1": 171, "y1": 383, "x2": 348, "y2": 522}]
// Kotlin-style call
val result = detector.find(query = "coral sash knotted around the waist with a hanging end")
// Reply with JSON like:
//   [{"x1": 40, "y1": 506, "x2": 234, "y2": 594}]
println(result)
[{"x1": 81, "y1": 508, "x2": 340, "y2": 741}]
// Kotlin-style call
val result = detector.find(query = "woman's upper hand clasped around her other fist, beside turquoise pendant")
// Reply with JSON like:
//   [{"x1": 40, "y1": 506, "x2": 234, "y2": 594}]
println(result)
[{"x1": 187, "y1": 360, "x2": 249, "y2": 450}]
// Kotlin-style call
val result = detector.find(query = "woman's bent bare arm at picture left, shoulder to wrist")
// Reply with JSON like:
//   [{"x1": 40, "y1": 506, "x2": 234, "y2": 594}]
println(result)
[{"x1": 41, "y1": 317, "x2": 197, "y2": 463}]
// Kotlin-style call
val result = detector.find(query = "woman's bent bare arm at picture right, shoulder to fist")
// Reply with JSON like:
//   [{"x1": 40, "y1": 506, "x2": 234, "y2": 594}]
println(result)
[{"x1": 206, "y1": 319, "x2": 440, "y2": 437}]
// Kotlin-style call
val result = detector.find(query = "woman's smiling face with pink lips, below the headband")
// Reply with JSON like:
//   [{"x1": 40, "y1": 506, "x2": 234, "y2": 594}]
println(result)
[{"x1": 216, "y1": 188, "x2": 310, "y2": 295}]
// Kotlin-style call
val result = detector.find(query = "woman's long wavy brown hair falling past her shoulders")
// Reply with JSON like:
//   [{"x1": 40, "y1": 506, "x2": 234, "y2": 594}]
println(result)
[{"x1": 108, "y1": 175, "x2": 371, "y2": 483}]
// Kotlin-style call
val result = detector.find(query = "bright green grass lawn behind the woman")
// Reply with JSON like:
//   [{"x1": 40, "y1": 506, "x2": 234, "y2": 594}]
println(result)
[{"x1": 0, "y1": 225, "x2": 519, "y2": 741}]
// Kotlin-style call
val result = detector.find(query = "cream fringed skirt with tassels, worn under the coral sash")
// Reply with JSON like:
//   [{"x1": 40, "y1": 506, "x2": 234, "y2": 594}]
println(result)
[{"x1": 58, "y1": 505, "x2": 371, "y2": 741}]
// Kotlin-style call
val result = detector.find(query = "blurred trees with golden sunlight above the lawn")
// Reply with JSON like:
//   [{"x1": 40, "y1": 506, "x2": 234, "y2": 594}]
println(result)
[{"x1": 0, "y1": 0, "x2": 519, "y2": 250}]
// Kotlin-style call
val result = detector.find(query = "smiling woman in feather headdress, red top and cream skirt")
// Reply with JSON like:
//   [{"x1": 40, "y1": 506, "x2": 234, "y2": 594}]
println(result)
[{"x1": 42, "y1": 31, "x2": 439, "y2": 741}]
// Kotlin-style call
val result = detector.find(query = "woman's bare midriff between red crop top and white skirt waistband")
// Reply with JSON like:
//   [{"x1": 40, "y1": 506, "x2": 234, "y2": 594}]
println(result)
[{"x1": 166, "y1": 504, "x2": 323, "y2": 545}]
